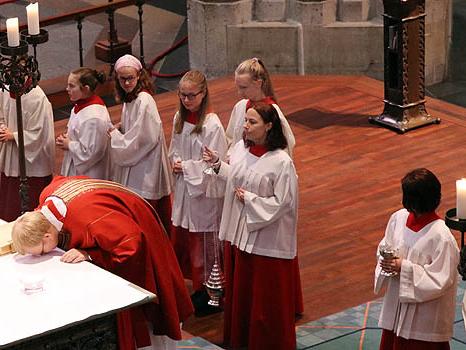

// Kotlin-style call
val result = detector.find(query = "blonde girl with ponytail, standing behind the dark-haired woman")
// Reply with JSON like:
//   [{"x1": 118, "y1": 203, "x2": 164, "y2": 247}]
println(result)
[{"x1": 226, "y1": 58, "x2": 296, "y2": 157}]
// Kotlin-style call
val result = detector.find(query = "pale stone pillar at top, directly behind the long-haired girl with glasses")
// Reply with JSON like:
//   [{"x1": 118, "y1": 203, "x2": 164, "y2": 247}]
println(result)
[{"x1": 188, "y1": 0, "x2": 253, "y2": 77}]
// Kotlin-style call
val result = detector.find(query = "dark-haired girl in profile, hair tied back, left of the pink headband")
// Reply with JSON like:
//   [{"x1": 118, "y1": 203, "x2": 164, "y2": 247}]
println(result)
[{"x1": 56, "y1": 68, "x2": 112, "y2": 179}]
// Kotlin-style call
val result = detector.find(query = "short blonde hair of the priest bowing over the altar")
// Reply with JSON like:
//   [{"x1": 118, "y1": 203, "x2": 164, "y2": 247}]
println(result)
[{"x1": 11, "y1": 211, "x2": 51, "y2": 255}]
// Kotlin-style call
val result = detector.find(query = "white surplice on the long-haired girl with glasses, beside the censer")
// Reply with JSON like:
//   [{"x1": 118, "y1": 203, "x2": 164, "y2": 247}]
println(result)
[{"x1": 169, "y1": 113, "x2": 227, "y2": 232}]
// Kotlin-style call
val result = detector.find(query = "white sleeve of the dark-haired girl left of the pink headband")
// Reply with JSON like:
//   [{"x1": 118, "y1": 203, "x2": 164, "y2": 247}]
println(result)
[{"x1": 68, "y1": 118, "x2": 108, "y2": 174}]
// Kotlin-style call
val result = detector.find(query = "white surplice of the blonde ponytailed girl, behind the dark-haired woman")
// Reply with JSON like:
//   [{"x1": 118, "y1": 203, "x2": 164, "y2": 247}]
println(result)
[{"x1": 225, "y1": 99, "x2": 296, "y2": 157}]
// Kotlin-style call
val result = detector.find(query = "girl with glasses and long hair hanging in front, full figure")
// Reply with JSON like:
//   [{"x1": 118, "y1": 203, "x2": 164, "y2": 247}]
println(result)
[{"x1": 169, "y1": 70, "x2": 227, "y2": 316}]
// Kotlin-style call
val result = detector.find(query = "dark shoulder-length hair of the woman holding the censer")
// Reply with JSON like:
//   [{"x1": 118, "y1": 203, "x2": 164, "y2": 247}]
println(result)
[{"x1": 243, "y1": 102, "x2": 288, "y2": 151}]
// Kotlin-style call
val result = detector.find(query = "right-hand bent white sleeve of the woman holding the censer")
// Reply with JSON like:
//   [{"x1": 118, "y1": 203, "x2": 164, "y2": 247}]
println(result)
[{"x1": 244, "y1": 161, "x2": 298, "y2": 232}]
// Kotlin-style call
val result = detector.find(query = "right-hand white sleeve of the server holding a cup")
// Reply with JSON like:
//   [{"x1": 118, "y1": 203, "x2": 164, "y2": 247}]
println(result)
[{"x1": 400, "y1": 238, "x2": 459, "y2": 303}]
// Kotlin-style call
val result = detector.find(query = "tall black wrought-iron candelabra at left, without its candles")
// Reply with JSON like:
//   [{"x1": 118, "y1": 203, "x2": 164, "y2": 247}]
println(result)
[{"x1": 0, "y1": 29, "x2": 48, "y2": 213}]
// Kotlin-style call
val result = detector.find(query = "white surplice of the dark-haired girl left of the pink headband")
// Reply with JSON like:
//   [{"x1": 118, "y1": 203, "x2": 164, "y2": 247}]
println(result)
[{"x1": 61, "y1": 104, "x2": 112, "y2": 180}]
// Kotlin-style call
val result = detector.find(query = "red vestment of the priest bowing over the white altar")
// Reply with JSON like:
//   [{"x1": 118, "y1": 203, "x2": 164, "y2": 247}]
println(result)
[{"x1": 40, "y1": 177, "x2": 193, "y2": 350}]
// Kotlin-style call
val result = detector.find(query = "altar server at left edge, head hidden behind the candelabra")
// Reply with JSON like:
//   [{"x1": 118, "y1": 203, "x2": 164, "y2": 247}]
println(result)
[{"x1": 0, "y1": 84, "x2": 55, "y2": 221}]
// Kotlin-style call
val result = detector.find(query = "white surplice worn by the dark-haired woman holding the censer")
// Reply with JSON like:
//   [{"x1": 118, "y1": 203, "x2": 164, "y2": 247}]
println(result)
[{"x1": 218, "y1": 140, "x2": 298, "y2": 259}]
